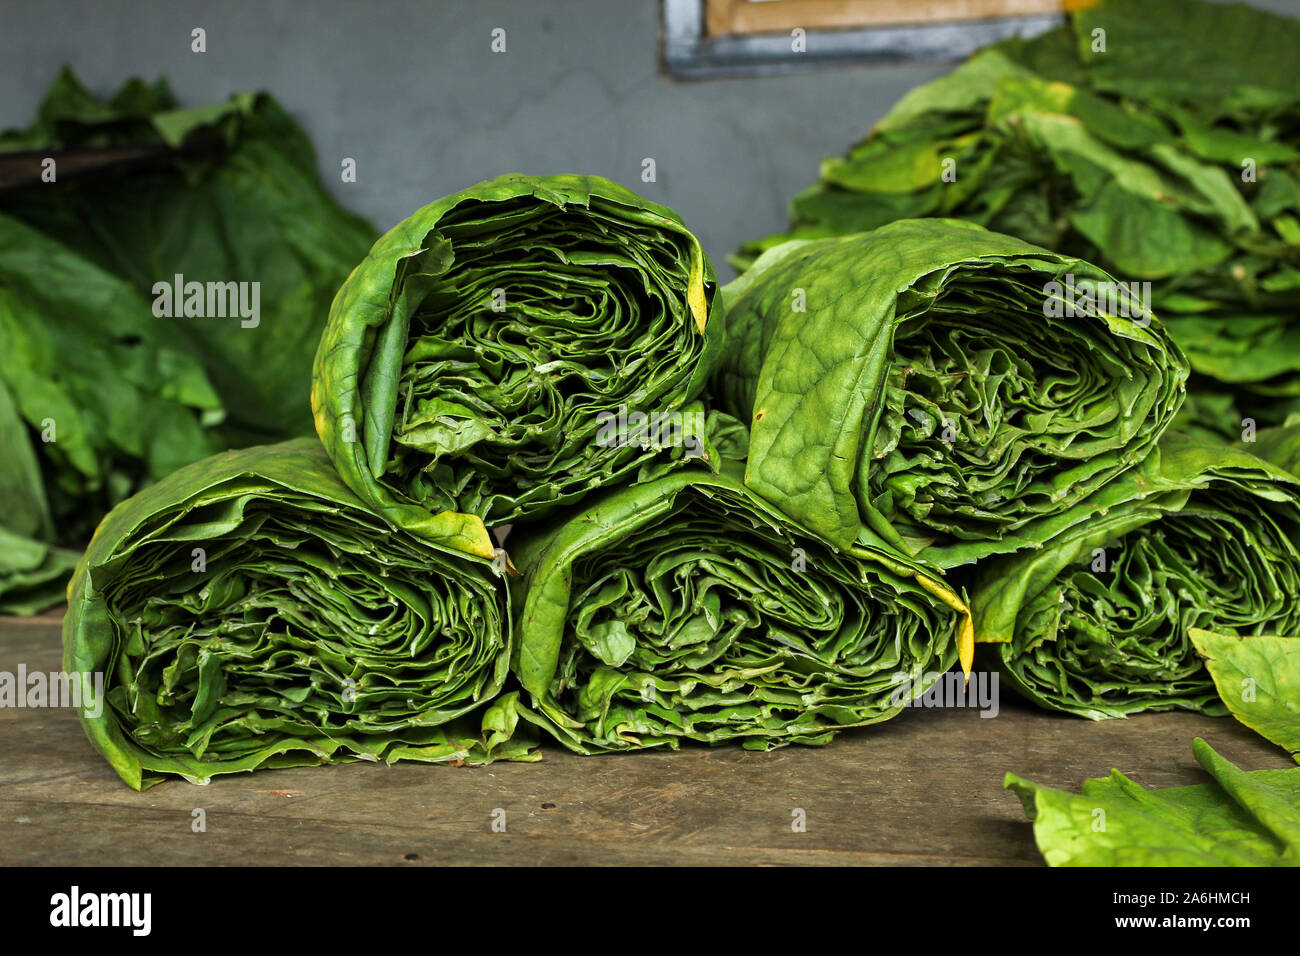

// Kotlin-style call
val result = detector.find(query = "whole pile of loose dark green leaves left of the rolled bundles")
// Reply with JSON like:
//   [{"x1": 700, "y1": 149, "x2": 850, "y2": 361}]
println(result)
[{"x1": 0, "y1": 70, "x2": 374, "y2": 613}]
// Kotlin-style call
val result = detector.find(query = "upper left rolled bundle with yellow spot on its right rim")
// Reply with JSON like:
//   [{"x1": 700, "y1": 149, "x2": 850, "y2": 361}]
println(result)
[{"x1": 312, "y1": 176, "x2": 722, "y2": 553}]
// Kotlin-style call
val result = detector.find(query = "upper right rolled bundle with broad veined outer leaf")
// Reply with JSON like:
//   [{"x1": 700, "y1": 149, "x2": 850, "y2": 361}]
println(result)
[{"x1": 714, "y1": 220, "x2": 1187, "y2": 567}]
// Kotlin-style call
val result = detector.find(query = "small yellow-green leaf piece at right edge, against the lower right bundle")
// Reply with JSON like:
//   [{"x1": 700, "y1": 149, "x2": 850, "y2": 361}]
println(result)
[{"x1": 1190, "y1": 628, "x2": 1300, "y2": 756}]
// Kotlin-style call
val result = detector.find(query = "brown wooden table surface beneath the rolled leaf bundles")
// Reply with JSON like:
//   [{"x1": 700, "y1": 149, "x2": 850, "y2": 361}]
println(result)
[{"x1": 0, "y1": 614, "x2": 1291, "y2": 866}]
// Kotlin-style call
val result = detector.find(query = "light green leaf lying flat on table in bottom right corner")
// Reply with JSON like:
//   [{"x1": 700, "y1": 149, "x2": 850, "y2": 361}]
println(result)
[{"x1": 1006, "y1": 737, "x2": 1300, "y2": 866}]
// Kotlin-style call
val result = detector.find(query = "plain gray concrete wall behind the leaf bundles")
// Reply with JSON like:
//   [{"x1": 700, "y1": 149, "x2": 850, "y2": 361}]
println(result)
[{"x1": 0, "y1": 0, "x2": 1300, "y2": 276}]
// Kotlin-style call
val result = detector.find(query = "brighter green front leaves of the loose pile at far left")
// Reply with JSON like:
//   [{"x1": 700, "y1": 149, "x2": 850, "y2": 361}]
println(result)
[{"x1": 0, "y1": 213, "x2": 225, "y2": 614}]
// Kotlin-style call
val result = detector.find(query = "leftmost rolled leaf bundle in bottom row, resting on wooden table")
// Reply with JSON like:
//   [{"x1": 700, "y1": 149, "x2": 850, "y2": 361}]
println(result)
[{"x1": 64, "y1": 438, "x2": 528, "y2": 790}]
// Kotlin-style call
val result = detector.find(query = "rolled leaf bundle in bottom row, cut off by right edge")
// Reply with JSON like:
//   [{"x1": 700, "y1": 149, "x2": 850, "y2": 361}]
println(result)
[{"x1": 971, "y1": 432, "x2": 1300, "y2": 719}]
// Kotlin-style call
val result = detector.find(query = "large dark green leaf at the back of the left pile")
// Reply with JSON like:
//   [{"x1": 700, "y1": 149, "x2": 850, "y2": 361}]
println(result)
[{"x1": 0, "y1": 70, "x2": 376, "y2": 442}]
